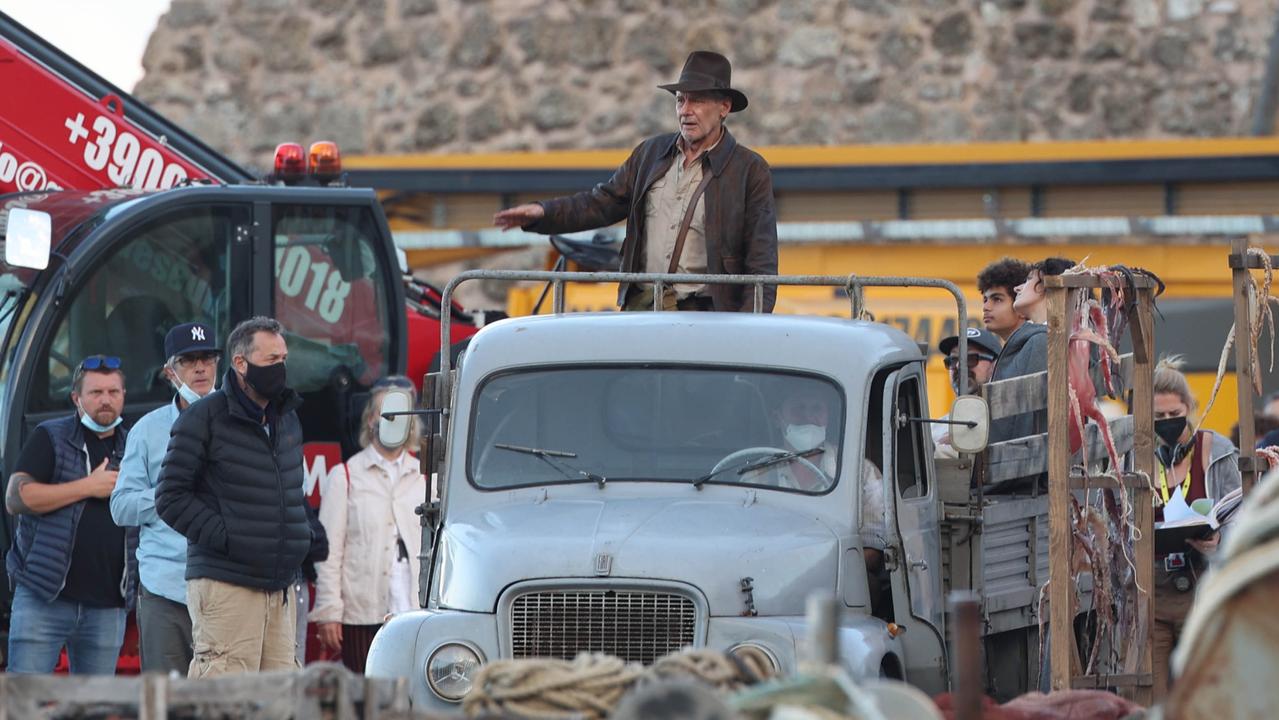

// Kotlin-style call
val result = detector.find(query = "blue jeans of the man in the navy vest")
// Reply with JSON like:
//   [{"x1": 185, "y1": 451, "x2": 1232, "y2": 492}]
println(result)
[{"x1": 9, "y1": 584, "x2": 125, "y2": 675}]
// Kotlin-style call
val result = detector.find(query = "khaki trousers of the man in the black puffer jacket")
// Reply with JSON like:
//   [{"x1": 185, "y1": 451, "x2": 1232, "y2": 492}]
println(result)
[{"x1": 187, "y1": 578, "x2": 302, "y2": 678}]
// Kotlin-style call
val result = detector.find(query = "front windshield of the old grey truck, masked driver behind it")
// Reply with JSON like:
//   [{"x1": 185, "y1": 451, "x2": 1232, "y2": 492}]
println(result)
[{"x1": 468, "y1": 367, "x2": 844, "y2": 494}]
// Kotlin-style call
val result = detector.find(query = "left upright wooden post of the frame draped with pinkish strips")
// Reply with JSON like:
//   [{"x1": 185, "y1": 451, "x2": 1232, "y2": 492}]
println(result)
[{"x1": 1045, "y1": 282, "x2": 1074, "y2": 691}]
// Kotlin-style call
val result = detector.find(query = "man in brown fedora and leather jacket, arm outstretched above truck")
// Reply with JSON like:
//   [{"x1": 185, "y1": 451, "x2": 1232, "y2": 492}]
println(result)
[{"x1": 492, "y1": 50, "x2": 778, "y2": 312}]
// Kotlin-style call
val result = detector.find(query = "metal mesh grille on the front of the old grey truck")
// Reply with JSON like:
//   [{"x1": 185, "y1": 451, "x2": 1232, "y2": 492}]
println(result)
[{"x1": 510, "y1": 590, "x2": 697, "y2": 664}]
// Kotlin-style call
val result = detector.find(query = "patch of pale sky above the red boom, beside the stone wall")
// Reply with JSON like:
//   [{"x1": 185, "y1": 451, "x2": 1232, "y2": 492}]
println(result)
[{"x1": 0, "y1": 0, "x2": 169, "y2": 92}]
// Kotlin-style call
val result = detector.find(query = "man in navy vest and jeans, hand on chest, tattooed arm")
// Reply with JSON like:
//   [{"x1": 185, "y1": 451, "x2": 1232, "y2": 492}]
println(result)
[{"x1": 5, "y1": 356, "x2": 130, "y2": 674}]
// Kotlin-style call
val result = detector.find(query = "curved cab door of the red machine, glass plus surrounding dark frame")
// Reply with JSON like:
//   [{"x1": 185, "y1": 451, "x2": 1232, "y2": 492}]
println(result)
[{"x1": 14, "y1": 203, "x2": 252, "y2": 436}]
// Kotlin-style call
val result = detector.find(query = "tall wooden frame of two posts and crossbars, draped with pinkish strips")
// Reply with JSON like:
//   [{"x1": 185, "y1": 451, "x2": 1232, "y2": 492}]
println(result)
[{"x1": 1044, "y1": 275, "x2": 1155, "y2": 706}]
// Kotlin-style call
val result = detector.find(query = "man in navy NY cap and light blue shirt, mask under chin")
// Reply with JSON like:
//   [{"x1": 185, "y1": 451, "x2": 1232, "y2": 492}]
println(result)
[{"x1": 111, "y1": 322, "x2": 221, "y2": 674}]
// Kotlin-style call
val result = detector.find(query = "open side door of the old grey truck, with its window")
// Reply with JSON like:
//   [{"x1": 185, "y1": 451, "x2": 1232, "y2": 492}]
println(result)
[{"x1": 883, "y1": 366, "x2": 946, "y2": 694}]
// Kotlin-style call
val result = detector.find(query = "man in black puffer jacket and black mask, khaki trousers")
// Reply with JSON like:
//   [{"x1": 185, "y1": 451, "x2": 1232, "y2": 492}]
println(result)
[{"x1": 156, "y1": 317, "x2": 312, "y2": 678}]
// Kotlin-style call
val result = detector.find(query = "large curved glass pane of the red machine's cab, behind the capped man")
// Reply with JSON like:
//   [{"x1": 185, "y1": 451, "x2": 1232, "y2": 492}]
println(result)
[{"x1": 31, "y1": 206, "x2": 249, "y2": 412}]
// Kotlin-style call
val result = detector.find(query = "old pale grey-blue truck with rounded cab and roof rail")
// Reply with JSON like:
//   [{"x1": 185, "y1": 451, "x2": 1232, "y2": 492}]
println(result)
[{"x1": 367, "y1": 271, "x2": 1115, "y2": 710}]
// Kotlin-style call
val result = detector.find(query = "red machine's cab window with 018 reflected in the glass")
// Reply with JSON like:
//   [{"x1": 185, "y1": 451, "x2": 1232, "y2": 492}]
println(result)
[{"x1": 272, "y1": 205, "x2": 390, "y2": 393}]
